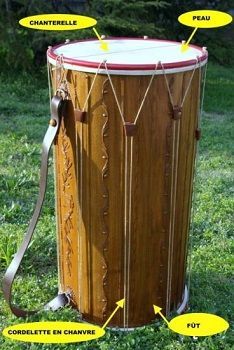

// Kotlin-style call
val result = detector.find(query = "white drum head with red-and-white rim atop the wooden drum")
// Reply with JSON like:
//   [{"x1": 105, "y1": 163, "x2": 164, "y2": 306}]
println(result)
[{"x1": 47, "y1": 38, "x2": 208, "y2": 75}]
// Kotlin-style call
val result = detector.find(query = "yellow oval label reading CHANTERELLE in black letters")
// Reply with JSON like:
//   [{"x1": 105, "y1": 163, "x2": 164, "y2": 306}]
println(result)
[{"x1": 19, "y1": 13, "x2": 97, "y2": 30}]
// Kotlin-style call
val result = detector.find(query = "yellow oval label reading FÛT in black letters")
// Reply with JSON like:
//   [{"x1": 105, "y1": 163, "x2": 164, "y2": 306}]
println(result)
[{"x1": 168, "y1": 313, "x2": 229, "y2": 337}]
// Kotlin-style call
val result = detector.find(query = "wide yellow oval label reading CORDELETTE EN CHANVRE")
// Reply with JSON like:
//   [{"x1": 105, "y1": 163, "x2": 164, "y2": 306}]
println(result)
[{"x1": 2, "y1": 322, "x2": 105, "y2": 343}]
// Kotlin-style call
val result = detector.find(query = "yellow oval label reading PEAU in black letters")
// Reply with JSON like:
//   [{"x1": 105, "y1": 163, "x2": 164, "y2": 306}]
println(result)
[{"x1": 178, "y1": 10, "x2": 232, "y2": 28}]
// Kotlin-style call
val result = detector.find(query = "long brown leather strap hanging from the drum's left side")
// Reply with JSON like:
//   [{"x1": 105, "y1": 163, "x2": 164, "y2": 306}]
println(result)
[{"x1": 3, "y1": 96, "x2": 69, "y2": 317}]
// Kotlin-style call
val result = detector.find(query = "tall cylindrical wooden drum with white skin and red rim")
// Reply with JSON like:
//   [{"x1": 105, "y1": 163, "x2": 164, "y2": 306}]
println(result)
[{"x1": 47, "y1": 38, "x2": 208, "y2": 328}]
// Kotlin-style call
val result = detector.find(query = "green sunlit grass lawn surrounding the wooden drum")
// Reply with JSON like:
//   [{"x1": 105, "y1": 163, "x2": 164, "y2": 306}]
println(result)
[{"x1": 0, "y1": 64, "x2": 234, "y2": 350}]
